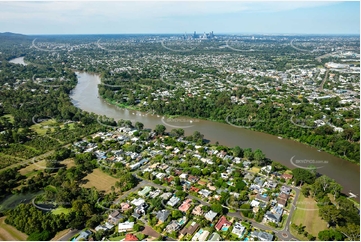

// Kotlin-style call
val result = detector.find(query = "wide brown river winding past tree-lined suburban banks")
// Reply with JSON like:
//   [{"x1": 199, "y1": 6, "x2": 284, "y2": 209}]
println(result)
[{"x1": 7, "y1": 58, "x2": 360, "y2": 201}]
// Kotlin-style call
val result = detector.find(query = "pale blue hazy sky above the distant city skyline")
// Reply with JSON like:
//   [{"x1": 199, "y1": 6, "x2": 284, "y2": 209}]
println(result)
[{"x1": 0, "y1": 0, "x2": 360, "y2": 35}]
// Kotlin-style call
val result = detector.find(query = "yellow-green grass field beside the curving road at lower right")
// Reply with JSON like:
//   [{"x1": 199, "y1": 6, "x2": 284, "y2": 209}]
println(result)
[{"x1": 291, "y1": 193, "x2": 327, "y2": 237}]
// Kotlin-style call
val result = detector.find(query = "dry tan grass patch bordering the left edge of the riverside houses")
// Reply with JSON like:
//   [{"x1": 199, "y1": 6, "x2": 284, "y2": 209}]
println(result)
[{"x1": 82, "y1": 169, "x2": 118, "y2": 193}]
